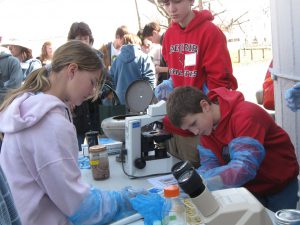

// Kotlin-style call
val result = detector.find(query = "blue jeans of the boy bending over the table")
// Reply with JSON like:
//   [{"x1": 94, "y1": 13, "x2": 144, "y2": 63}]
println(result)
[{"x1": 255, "y1": 178, "x2": 299, "y2": 212}]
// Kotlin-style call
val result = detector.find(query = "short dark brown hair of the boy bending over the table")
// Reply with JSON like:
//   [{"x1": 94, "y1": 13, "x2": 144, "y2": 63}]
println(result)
[{"x1": 167, "y1": 86, "x2": 211, "y2": 127}]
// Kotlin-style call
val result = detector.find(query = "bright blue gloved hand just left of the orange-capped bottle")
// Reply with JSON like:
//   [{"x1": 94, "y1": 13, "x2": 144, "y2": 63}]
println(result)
[{"x1": 130, "y1": 193, "x2": 164, "y2": 225}]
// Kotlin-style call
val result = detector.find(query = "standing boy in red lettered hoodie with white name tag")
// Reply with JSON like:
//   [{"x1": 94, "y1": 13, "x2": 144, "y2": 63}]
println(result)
[{"x1": 155, "y1": 0, "x2": 238, "y2": 166}]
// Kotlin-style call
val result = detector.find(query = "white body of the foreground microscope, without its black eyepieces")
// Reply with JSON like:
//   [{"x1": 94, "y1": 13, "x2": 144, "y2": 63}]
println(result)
[{"x1": 192, "y1": 188, "x2": 273, "y2": 225}]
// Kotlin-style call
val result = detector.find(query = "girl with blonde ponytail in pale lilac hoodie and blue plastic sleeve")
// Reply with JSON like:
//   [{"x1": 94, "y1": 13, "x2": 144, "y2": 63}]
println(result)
[{"x1": 0, "y1": 41, "x2": 139, "y2": 225}]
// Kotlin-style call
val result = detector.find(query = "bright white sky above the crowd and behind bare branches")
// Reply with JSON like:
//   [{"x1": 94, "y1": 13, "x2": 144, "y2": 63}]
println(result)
[{"x1": 0, "y1": 0, "x2": 269, "y2": 55}]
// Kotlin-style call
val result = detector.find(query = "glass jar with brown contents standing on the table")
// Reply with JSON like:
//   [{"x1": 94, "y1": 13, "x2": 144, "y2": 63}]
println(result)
[{"x1": 89, "y1": 145, "x2": 109, "y2": 180}]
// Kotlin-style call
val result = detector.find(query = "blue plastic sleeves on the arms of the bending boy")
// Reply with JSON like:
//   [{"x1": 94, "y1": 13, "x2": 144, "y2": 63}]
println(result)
[{"x1": 197, "y1": 137, "x2": 266, "y2": 191}]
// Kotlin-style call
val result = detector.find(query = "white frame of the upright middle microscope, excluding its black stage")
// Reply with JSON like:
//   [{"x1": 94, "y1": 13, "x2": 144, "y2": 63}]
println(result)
[{"x1": 124, "y1": 101, "x2": 175, "y2": 177}]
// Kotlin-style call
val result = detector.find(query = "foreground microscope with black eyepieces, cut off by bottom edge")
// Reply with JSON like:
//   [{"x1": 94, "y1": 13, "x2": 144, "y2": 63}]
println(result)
[{"x1": 172, "y1": 161, "x2": 273, "y2": 225}]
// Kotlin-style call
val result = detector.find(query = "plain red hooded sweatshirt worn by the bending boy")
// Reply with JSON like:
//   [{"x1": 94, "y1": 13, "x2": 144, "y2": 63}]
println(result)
[{"x1": 201, "y1": 88, "x2": 299, "y2": 195}]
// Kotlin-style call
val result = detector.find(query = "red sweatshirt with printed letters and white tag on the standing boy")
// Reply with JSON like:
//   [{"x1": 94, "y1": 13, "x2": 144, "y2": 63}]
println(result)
[{"x1": 163, "y1": 10, "x2": 238, "y2": 90}]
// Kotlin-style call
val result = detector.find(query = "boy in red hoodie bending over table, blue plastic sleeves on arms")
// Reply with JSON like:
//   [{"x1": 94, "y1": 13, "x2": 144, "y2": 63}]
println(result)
[{"x1": 167, "y1": 87, "x2": 299, "y2": 212}]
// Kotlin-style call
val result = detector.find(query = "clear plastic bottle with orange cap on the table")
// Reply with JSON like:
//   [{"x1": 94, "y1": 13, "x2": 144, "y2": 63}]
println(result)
[{"x1": 163, "y1": 185, "x2": 186, "y2": 225}]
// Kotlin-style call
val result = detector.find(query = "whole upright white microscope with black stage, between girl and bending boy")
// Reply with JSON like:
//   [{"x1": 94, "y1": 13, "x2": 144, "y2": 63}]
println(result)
[{"x1": 123, "y1": 101, "x2": 177, "y2": 178}]
